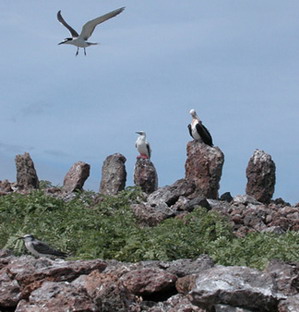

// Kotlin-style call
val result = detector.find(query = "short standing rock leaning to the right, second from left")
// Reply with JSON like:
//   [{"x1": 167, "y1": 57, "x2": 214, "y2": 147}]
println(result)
[{"x1": 63, "y1": 161, "x2": 90, "y2": 193}]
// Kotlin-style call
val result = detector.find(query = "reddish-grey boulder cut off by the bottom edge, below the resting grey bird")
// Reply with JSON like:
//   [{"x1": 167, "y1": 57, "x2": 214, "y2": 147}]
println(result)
[{"x1": 15, "y1": 282, "x2": 99, "y2": 312}]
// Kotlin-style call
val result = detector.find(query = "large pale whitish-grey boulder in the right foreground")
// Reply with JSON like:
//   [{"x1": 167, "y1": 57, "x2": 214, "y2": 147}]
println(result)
[{"x1": 189, "y1": 266, "x2": 283, "y2": 312}]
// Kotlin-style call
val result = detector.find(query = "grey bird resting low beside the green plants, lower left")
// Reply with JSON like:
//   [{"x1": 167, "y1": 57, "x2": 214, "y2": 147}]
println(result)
[{"x1": 19, "y1": 234, "x2": 67, "y2": 259}]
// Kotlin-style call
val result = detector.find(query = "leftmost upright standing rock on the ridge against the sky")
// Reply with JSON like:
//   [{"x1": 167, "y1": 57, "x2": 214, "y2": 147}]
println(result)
[{"x1": 15, "y1": 153, "x2": 39, "y2": 189}]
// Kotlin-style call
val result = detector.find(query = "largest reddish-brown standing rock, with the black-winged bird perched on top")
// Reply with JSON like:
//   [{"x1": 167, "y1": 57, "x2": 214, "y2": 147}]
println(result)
[{"x1": 185, "y1": 141, "x2": 224, "y2": 199}]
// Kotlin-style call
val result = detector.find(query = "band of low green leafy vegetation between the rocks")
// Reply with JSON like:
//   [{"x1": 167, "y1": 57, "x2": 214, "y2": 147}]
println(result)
[{"x1": 0, "y1": 188, "x2": 299, "y2": 268}]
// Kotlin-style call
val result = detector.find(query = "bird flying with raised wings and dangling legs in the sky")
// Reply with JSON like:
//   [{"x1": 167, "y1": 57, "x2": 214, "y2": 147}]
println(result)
[{"x1": 57, "y1": 7, "x2": 125, "y2": 55}]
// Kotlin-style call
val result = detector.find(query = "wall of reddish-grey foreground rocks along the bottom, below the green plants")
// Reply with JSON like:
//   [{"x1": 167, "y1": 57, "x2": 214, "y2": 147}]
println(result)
[{"x1": 0, "y1": 254, "x2": 299, "y2": 312}]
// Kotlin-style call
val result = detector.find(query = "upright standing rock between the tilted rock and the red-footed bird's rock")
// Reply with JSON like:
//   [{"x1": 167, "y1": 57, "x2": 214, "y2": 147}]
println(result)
[{"x1": 100, "y1": 153, "x2": 127, "y2": 195}]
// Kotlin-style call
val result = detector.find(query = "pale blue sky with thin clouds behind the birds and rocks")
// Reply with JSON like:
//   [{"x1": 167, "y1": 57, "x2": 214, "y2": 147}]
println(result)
[{"x1": 0, "y1": 0, "x2": 299, "y2": 203}]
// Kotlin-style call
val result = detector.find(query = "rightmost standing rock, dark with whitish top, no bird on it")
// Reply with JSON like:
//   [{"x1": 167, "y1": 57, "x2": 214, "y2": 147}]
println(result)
[{"x1": 246, "y1": 150, "x2": 276, "y2": 203}]
